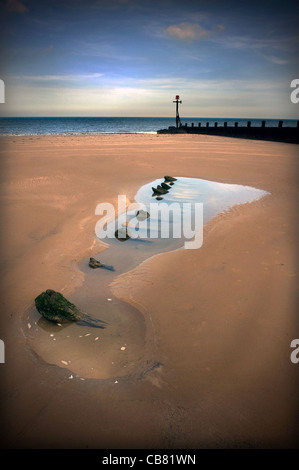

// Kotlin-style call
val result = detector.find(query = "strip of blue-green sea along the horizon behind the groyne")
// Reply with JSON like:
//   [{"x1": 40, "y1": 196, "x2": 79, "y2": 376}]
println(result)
[{"x1": 0, "y1": 117, "x2": 297, "y2": 136}]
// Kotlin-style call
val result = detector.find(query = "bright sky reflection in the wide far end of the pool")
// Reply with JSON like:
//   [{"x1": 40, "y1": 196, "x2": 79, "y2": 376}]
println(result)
[{"x1": 97, "y1": 177, "x2": 267, "y2": 254}]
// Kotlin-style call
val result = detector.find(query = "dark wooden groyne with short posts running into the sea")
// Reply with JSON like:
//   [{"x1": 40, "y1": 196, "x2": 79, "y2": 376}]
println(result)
[{"x1": 157, "y1": 121, "x2": 299, "y2": 144}]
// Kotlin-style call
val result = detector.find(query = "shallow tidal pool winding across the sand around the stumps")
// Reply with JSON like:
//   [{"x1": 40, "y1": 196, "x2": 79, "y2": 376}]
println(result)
[{"x1": 25, "y1": 177, "x2": 267, "y2": 379}]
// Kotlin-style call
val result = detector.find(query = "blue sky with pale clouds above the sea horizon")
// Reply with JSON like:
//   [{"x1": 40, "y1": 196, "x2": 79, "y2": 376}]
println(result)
[{"x1": 0, "y1": 0, "x2": 299, "y2": 119}]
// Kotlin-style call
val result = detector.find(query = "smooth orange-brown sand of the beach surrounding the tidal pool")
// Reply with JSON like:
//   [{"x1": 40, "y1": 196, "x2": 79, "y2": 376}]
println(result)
[{"x1": 0, "y1": 135, "x2": 299, "y2": 449}]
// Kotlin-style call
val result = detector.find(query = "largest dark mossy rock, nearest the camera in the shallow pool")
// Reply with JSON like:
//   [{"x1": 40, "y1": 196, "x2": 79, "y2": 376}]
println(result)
[{"x1": 35, "y1": 289, "x2": 105, "y2": 328}]
